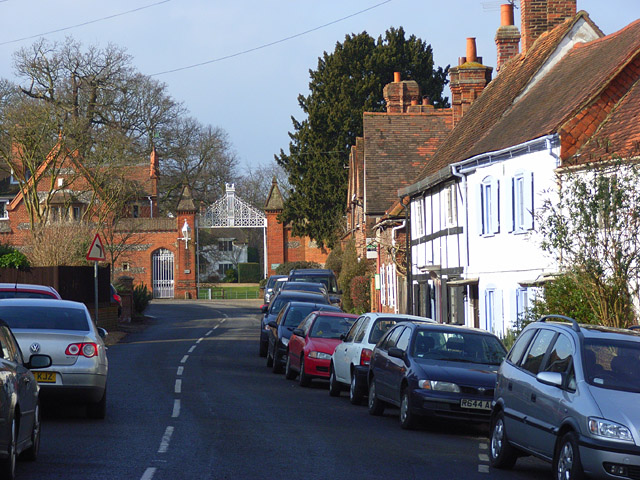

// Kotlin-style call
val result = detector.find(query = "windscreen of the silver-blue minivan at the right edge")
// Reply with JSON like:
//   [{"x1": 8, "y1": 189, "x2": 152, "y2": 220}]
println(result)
[{"x1": 583, "y1": 338, "x2": 640, "y2": 392}]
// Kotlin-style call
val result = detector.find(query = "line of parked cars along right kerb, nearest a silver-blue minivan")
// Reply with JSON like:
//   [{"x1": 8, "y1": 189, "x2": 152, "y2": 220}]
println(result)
[{"x1": 260, "y1": 276, "x2": 640, "y2": 480}]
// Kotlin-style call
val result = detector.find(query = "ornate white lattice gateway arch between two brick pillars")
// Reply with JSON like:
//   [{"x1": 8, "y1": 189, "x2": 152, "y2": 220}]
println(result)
[{"x1": 196, "y1": 183, "x2": 267, "y2": 282}]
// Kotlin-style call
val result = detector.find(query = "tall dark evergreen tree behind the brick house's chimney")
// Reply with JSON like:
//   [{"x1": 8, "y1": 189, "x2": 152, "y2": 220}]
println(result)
[{"x1": 276, "y1": 27, "x2": 448, "y2": 247}]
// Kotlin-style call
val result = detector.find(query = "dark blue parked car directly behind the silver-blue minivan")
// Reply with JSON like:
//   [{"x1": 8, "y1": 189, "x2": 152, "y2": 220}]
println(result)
[{"x1": 369, "y1": 322, "x2": 507, "y2": 428}]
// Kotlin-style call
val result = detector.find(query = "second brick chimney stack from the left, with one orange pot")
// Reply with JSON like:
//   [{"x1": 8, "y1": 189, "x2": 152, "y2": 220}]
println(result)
[{"x1": 449, "y1": 38, "x2": 493, "y2": 126}]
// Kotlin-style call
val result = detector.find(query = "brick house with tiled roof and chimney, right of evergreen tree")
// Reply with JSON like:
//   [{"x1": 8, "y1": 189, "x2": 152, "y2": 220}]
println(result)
[{"x1": 342, "y1": 72, "x2": 453, "y2": 312}]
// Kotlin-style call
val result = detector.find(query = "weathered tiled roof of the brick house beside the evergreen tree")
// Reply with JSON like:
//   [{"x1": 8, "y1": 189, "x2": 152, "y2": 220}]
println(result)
[{"x1": 364, "y1": 109, "x2": 453, "y2": 215}]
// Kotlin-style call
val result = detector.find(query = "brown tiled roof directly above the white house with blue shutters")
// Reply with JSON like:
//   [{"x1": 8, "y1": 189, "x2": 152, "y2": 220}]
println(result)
[{"x1": 467, "y1": 16, "x2": 640, "y2": 157}]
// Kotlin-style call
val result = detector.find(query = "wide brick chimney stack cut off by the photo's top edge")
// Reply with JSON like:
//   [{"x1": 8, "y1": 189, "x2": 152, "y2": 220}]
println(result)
[{"x1": 520, "y1": 0, "x2": 577, "y2": 53}]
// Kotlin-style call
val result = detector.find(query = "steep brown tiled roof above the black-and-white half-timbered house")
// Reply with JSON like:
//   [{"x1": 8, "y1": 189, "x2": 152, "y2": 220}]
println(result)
[{"x1": 408, "y1": 11, "x2": 603, "y2": 188}]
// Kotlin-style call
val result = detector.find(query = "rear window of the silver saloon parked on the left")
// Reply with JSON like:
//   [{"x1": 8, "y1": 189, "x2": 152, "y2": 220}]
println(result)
[{"x1": 0, "y1": 306, "x2": 90, "y2": 332}]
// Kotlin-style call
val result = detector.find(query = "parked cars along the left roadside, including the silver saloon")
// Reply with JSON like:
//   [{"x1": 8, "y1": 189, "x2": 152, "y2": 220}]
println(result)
[{"x1": 0, "y1": 284, "x2": 108, "y2": 479}]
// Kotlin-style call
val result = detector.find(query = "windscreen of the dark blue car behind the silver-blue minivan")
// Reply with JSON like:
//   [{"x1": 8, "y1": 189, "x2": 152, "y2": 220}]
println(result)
[{"x1": 412, "y1": 329, "x2": 507, "y2": 365}]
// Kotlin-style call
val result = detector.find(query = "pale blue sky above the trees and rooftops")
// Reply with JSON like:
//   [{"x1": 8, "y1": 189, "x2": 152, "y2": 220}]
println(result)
[{"x1": 0, "y1": 0, "x2": 640, "y2": 173}]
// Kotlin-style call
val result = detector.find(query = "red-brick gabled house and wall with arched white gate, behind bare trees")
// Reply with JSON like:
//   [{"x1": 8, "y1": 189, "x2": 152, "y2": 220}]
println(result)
[{"x1": 0, "y1": 144, "x2": 196, "y2": 298}]
